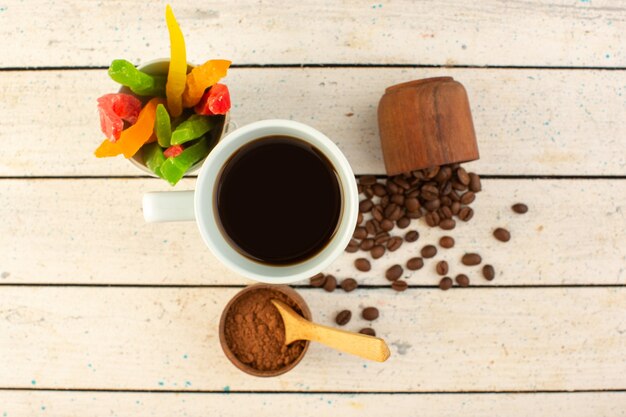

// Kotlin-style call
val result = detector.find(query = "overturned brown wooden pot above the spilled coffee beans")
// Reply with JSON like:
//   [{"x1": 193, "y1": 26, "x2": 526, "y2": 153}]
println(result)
[{"x1": 378, "y1": 77, "x2": 479, "y2": 175}]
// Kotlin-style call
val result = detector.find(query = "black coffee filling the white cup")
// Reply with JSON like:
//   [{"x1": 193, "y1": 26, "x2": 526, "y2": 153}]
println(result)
[{"x1": 214, "y1": 136, "x2": 342, "y2": 265}]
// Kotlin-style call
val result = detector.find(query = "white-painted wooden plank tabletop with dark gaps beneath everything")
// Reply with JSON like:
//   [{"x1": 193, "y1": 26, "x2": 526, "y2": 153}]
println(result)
[{"x1": 0, "y1": 0, "x2": 626, "y2": 417}]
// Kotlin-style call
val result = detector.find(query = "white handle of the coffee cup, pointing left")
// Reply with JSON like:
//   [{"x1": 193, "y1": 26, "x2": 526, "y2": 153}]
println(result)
[{"x1": 143, "y1": 190, "x2": 196, "y2": 223}]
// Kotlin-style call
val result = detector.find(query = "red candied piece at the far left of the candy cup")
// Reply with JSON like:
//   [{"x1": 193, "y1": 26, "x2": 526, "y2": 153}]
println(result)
[{"x1": 98, "y1": 93, "x2": 141, "y2": 142}]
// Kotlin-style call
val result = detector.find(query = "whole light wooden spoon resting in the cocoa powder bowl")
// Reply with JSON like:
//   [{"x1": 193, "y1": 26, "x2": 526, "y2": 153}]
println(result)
[{"x1": 272, "y1": 300, "x2": 390, "y2": 362}]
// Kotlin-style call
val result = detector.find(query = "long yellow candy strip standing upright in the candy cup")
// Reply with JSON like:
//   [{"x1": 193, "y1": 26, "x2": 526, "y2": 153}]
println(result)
[{"x1": 165, "y1": 4, "x2": 187, "y2": 117}]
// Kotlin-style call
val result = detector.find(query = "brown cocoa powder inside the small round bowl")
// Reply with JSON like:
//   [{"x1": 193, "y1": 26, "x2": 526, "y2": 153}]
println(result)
[{"x1": 224, "y1": 289, "x2": 305, "y2": 371}]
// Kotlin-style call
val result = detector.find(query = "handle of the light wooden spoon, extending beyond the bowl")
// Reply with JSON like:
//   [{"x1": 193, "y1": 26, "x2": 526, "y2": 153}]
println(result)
[{"x1": 302, "y1": 322, "x2": 390, "y2": 362}]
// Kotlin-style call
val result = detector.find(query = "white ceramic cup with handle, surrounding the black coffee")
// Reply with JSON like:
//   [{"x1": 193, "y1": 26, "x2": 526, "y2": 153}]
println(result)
[{"x1": 143, "y1": 120, "x2": 359, "y2": 284}]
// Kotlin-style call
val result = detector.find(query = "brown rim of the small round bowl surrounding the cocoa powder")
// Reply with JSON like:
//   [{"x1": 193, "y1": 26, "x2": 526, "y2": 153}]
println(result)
[{"x1": 219, "y1": 284, "x2": 312, "y2": 378}]
